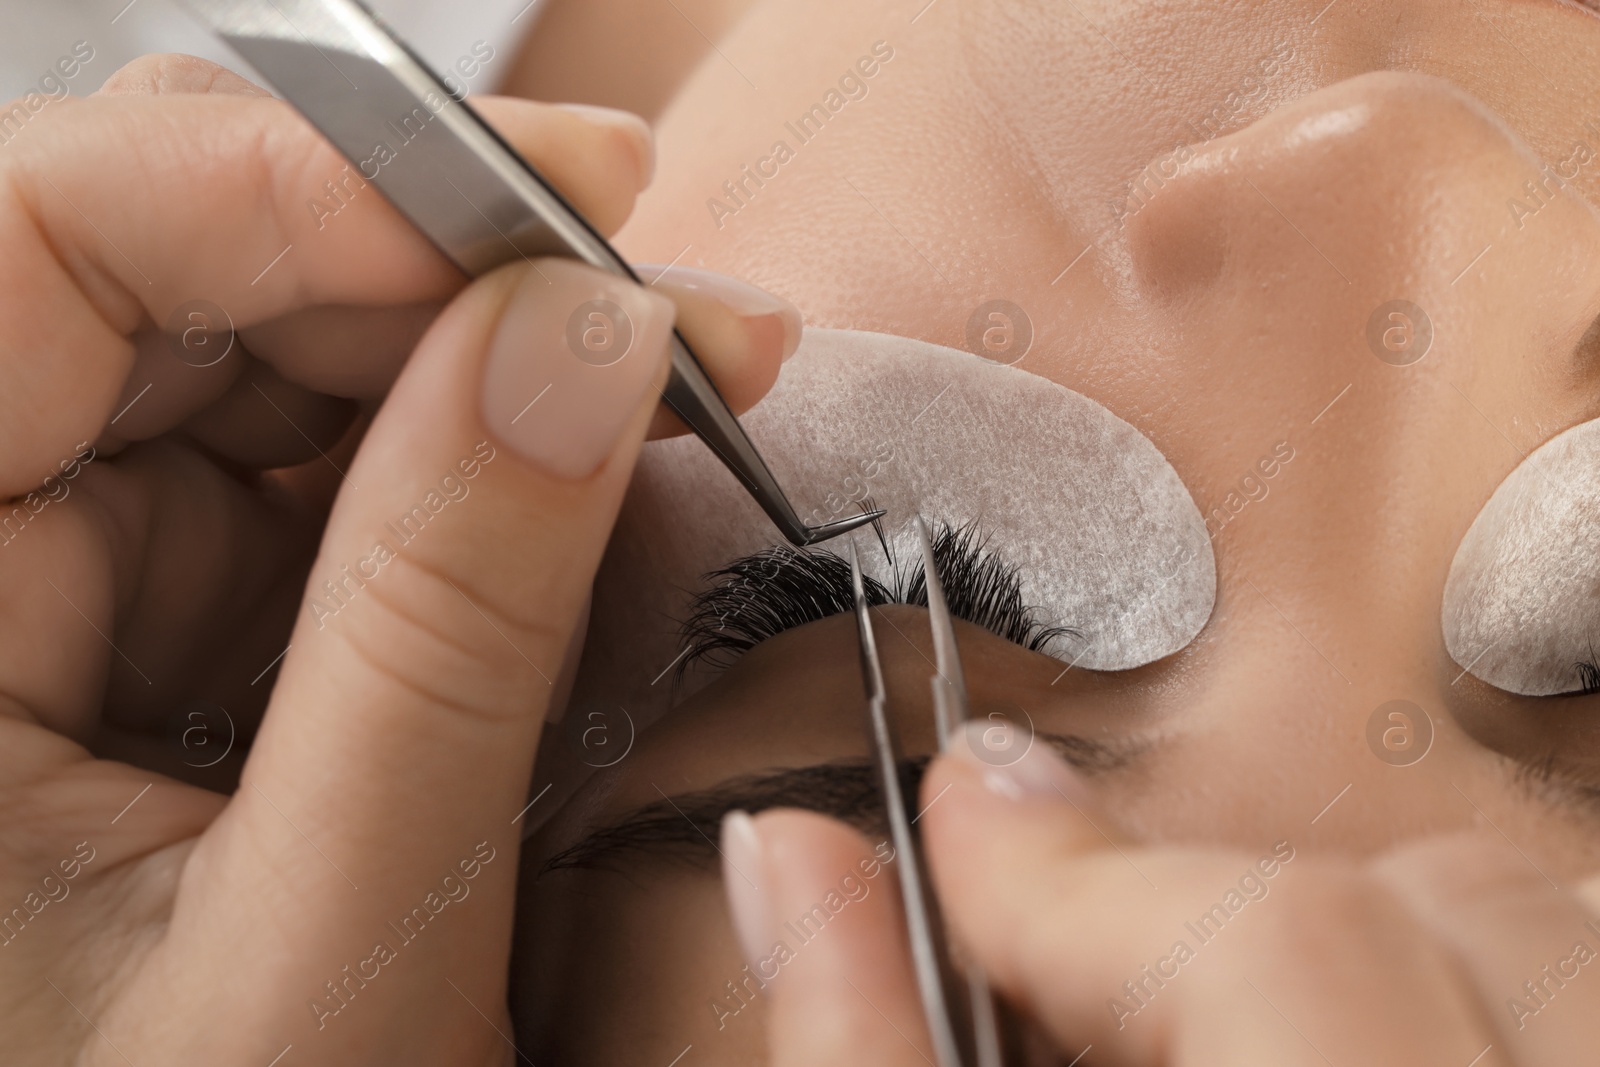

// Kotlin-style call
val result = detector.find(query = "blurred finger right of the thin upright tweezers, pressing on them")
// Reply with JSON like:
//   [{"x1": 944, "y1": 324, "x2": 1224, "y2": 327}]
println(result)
[{"x1": 922, "y1": 726, "x2": 1507, "y2": 1067}]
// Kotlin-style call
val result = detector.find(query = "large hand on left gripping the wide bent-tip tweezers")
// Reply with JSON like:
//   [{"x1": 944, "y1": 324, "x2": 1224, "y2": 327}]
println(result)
[{"x1": 0, "y1": 59, "x2": 798, "y2": 1067}]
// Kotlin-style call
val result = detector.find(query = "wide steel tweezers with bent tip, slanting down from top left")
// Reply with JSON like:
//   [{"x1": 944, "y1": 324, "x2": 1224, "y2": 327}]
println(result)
[{"x1": 182, "y1": 0, "x2": 880, "y2": 545}]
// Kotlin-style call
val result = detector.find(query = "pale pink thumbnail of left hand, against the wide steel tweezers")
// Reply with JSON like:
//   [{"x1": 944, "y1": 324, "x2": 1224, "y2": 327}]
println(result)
[{"x1": 483, "y1": 259, "x2": 675, "y2": 478}]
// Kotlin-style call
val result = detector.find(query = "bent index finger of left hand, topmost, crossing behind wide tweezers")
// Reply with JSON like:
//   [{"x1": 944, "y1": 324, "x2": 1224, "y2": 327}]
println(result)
[{"x1": 0, "y1": 93, "x2": 648, "y2": 494}]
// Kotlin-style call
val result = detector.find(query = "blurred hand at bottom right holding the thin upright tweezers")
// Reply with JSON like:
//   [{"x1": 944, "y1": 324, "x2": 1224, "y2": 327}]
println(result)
[{"x1": 746, "y1": 735, "x2": 1600, "y2": 1067}]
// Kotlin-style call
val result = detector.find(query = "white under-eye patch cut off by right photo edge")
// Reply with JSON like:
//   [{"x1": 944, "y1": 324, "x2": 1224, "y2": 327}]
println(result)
[{"x1": 1442, "y1": 419, "x2": 1600, "y2": 696}]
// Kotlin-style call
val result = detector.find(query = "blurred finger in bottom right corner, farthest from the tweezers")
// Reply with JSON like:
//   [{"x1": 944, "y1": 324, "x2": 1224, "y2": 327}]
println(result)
[{"x1": 1376, "y1": 835, "x2": 1600, "y2": 1067}]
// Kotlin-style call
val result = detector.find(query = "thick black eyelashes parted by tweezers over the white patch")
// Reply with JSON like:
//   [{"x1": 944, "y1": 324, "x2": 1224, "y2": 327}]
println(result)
[{"x1": 678, "y1": 515, "x2": 1080, "y2": 678}]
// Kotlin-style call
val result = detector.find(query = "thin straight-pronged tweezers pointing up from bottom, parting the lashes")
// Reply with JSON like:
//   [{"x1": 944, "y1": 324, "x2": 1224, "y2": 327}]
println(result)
[{"x1": 850, "y1": 517, "x2": 1003, "y2": 1067}]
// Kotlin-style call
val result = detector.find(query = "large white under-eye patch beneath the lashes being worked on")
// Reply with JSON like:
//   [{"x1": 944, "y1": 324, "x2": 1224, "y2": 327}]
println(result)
[{"x1": 574, "y1": 330, "x2": 1216, "y2": 729}]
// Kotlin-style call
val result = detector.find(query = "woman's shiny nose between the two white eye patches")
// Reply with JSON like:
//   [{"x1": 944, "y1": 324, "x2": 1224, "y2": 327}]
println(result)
[{"x1": 1126, "y1": 74, "x2": 1600, "y2": 848}]
